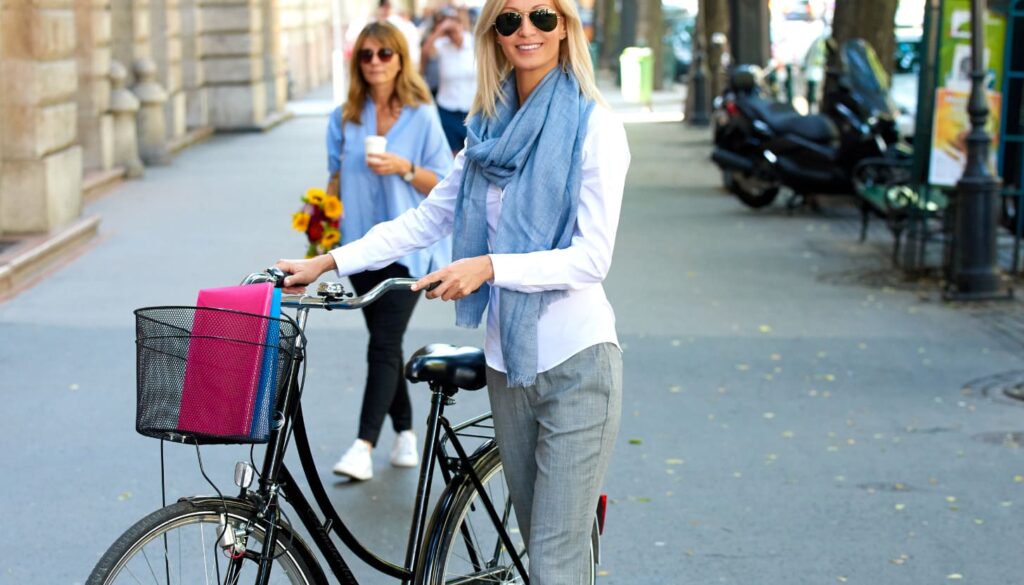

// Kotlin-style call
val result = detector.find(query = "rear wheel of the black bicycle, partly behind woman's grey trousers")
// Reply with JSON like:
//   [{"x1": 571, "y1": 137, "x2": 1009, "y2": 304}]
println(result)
[{"x1": 420, "y1": 449, "x2": 597, "y2": 585}]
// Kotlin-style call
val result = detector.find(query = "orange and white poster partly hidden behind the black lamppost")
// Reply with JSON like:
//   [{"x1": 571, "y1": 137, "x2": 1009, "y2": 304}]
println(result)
[{"x1": 928, "y1": 87, "x2": 1001, "y2": 186}]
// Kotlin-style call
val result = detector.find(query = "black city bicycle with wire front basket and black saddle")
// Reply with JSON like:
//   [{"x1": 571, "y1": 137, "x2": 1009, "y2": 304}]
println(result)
[{"x1": 87, "y1": 268, "x2": 605, "y2": 585}]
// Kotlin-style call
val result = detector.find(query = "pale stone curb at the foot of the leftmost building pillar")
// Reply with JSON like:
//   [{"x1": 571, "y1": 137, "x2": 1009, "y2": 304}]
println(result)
[{"x1": 0, "y1": 215, "x2": 99, "y2": 301}]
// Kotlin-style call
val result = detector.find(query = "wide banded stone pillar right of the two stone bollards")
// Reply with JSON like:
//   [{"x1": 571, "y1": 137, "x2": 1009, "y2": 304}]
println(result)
[{"x1": 199, "y1": 0, "x2": 267, "y2": 130}]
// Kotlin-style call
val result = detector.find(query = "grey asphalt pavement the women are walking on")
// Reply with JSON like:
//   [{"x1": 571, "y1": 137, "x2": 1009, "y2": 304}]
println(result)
[{"x1": 0, "y1": 83, "x2": 1024, "y2": 585}]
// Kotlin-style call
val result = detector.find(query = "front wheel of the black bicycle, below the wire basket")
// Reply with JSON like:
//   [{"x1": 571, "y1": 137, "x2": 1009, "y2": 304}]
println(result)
[{"x1": 86, "y1": 499, "x2": 326, "y2": 585}]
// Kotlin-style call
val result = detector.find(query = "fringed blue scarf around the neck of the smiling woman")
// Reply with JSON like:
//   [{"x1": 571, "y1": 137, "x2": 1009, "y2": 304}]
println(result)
[{"x1": 453, "y1": 67, "x2": 594, "y2": 386}]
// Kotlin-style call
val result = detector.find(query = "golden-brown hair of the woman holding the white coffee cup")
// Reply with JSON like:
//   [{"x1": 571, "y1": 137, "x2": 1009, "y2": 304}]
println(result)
[{"x1": 341, "y1": 22, "x2": 432, "y2": 124}]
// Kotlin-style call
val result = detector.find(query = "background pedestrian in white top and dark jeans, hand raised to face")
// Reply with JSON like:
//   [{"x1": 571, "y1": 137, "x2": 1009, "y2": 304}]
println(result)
[{"x1": 423, "y1": 8, "x2": 476, "y2": 153}]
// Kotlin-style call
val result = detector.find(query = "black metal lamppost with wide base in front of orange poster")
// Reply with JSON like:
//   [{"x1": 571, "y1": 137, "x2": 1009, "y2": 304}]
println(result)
[{"x1": 949, "y1": 0, "x2": 1007, "y2": 300}]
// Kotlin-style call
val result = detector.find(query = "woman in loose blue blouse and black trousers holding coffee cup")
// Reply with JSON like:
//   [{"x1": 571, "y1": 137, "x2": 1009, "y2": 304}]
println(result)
[{"x1": 327, "y1": 22, "x2": 452, "y2": 480}]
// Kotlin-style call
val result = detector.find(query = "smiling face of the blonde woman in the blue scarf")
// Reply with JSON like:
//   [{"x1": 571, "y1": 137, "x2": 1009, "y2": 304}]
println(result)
[{"x1": 495, "y1": 0, "x2": 565, "y2": 75}]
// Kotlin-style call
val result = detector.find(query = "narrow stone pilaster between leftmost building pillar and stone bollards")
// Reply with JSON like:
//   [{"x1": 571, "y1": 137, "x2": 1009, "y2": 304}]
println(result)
[{"x1": 75, "y1": 0, "x2": 114, "y2": 172}]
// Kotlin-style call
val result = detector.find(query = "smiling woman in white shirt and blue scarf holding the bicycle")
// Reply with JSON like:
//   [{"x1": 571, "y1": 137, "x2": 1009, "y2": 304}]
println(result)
[{"x1": 278, "y1": 0, "x2": 630, "y2": 585}]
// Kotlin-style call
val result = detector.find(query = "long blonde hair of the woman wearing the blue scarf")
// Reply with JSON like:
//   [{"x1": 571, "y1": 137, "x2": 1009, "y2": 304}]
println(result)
[{"x1": 469, "y1": 0, "x2": 605, "y2": 117}]
